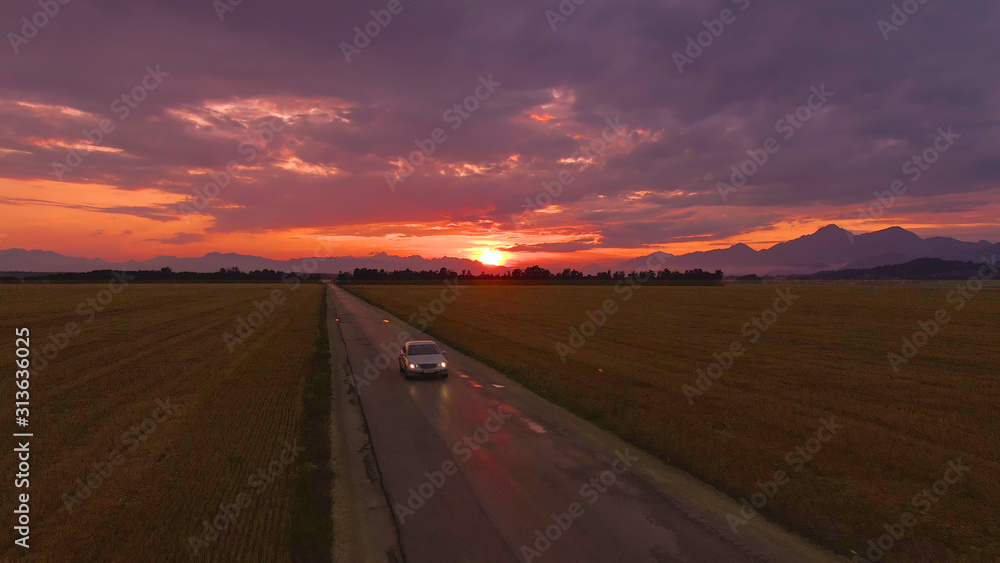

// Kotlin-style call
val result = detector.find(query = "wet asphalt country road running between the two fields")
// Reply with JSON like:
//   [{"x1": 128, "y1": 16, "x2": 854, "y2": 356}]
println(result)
[{"x1": 329, "y1": 285, "x2": 846, "y2": 563}]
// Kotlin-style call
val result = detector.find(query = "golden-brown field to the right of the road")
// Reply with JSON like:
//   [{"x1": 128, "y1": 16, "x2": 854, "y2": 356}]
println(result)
[{"x1": 347, "y1": 282, "x2": 1000, "y2": 561}]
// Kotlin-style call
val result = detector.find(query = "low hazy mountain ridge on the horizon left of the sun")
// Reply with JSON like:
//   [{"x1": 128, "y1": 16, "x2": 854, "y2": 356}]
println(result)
[{"x1": 0, "y1": 248, "x2": 507, "y2": 274}]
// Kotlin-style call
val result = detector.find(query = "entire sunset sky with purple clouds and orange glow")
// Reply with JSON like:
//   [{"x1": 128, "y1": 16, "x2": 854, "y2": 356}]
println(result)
[{"x1": 0, "y1": 0, "x2": 1000, "y2": 265}]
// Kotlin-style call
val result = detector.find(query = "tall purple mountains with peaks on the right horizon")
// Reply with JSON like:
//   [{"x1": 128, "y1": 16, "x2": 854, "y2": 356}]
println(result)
[{"x1": 618, "y1": 225, "x2": 1000, "y2": 275}]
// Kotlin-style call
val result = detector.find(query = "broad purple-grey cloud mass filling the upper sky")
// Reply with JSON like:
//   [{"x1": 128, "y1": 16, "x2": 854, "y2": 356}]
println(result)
[{"x1": 0, "y1": 0, "x2": 1000, "y2": 248}]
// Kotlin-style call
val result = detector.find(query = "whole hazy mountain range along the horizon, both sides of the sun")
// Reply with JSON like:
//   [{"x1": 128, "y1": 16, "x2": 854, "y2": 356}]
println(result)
[{"x1": 0, "y1": 225, "x2": 1000, "y2": 275}]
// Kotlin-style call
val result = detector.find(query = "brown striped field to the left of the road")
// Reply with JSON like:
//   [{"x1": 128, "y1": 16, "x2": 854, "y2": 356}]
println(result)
[{"x1": 0, "y1": 283, "x2": 332, "y2": 561}]
